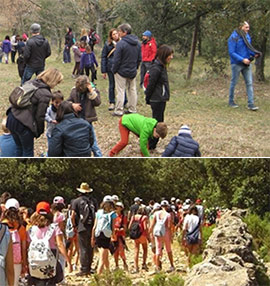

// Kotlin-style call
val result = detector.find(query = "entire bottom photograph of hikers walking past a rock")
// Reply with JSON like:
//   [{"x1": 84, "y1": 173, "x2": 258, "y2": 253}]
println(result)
[{"x1": 0, "y1": 158, "x2": 270, "y2": 286}]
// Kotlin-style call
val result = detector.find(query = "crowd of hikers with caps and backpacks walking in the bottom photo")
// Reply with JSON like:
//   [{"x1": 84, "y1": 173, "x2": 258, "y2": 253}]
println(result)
[{"x1": 0, "y1": 187, "x2": 207, "y2": 286}]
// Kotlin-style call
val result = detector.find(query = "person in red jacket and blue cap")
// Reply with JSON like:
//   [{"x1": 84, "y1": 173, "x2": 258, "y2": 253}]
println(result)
[{"x1": 140, "y1": 30, "x2": 157, "y2": 87}]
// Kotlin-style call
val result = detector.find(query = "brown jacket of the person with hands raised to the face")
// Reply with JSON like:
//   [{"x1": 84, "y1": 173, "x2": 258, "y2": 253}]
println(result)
[{"x1": 67, "y1": 87, "x2": 101, "y2": 123}]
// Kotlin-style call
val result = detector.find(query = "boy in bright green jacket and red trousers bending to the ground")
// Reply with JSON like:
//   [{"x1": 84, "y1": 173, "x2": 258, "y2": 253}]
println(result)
[{"x1": 109, "y1": 113, "x2": 168, "y2": 157}]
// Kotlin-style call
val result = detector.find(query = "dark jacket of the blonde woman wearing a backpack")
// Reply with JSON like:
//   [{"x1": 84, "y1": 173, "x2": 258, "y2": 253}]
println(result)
[{"x1": 11, "y1": 79, "x2": 52, "y2": 138}]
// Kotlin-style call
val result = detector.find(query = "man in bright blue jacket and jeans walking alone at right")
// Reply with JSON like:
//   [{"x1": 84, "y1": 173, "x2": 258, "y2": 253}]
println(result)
[{"x1": 228, "y1": 22, "x2": 259, "y2": 111}]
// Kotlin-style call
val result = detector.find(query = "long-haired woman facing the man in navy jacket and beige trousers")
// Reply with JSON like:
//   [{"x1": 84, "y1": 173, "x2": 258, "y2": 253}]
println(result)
[{"x1": 101, "y1": 29, "x2": 120, "y2": 110}]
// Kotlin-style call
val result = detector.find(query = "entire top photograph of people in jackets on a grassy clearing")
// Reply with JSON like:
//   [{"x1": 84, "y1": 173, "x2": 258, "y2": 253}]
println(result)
[{"x1": 0, "y1": 0, "x2": 270, "y2": 158}]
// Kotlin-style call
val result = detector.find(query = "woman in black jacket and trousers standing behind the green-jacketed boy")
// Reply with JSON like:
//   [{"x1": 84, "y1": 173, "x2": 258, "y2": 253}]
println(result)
[{"x1": 145, "y1": 45, "x2": 173, "y2": 150}]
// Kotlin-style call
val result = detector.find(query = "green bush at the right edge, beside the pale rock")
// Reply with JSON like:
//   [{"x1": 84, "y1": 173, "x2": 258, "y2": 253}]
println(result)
[{"x1": 244, "y1": 213, "x2": 270, "y2": 262}]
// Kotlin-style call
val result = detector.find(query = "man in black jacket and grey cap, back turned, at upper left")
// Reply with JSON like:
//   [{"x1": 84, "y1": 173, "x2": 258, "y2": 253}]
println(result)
[{"x1": 21, "y1": 23, "x2": 51, "y2": 85}]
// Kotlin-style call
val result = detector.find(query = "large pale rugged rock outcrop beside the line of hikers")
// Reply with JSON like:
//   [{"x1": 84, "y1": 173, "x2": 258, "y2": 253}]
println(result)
[{"x1": 185, "y1": 210, "x2": 264, "y2": 286}]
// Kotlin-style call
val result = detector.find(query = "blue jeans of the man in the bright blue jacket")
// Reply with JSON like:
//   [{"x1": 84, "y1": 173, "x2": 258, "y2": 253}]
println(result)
[{"x1": 229, "y1": 64, "x2": 254, "y2": 106}]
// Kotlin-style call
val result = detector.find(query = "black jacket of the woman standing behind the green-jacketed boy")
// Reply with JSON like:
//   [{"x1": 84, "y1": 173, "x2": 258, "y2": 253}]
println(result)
[{"x1": 145, "y1": 59, "x2": 170, "y2": 103}]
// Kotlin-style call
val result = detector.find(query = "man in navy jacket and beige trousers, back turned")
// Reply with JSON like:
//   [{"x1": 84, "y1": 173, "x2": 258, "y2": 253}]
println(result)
[{"x1": 112, "y1": 24, "x2": 141, "y2": 116}]
